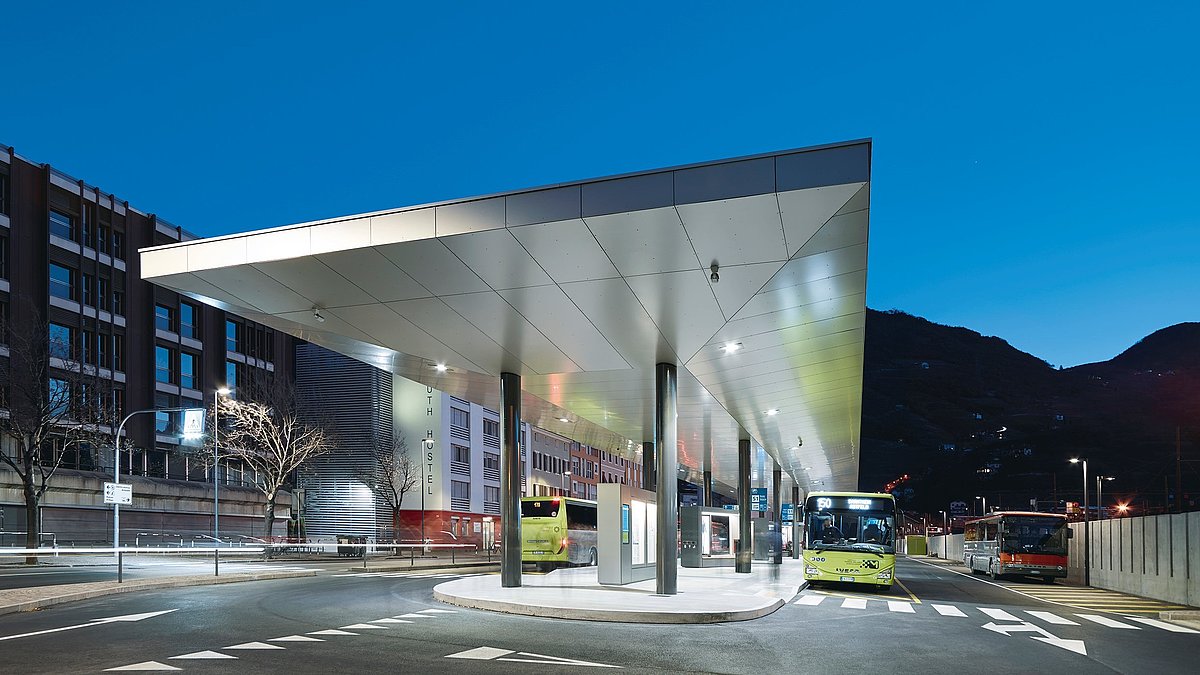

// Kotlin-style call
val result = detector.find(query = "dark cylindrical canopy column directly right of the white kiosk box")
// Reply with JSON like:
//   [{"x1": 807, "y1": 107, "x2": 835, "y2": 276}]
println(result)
[{"x1": 654, "y1": 363, "x2": 679, "y2": 596}]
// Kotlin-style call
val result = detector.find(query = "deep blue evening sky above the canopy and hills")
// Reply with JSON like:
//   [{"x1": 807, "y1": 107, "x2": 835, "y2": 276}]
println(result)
[{"x1": 0, "y1": 1, "x2": 1200, "y2": 365}]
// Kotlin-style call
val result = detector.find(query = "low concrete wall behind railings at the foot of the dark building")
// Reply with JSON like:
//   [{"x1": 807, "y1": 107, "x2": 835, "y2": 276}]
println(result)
[{"x1": 0, "y1": 470, "x2": 292, "y2": 545}]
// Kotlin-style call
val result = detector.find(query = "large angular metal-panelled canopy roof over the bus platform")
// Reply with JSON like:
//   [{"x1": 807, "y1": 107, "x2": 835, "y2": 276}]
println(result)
[{"x1": 140, "y1": 141, "x2": 871, "y2": 494}]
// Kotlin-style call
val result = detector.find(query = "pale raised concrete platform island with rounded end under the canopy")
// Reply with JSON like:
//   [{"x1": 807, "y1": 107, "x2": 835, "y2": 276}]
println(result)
[{"x1": 433, "y1": 558, "x2": 805, "y2": 623}]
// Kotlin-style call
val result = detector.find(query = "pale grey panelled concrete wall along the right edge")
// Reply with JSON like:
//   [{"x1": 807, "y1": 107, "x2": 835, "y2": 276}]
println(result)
[{"x1": 1069, "y1": 513, "x2": 1200, "y2": 607}]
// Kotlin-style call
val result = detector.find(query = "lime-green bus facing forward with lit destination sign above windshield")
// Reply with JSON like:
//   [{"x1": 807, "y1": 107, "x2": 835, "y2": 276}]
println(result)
[{"x1": 802, "y1": 492, "x2": 896, "y2": 591}]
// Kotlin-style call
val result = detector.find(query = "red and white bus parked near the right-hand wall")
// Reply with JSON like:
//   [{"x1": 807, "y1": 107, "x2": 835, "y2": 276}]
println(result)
[{"x1": 962, "y1": 510, "x2": 1070, "y2": 584}]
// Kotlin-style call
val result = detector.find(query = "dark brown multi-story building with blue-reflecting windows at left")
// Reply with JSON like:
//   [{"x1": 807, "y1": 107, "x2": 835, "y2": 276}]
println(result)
[{"x1": 0, "y1": 145, "x2": 294, "y2": 540}]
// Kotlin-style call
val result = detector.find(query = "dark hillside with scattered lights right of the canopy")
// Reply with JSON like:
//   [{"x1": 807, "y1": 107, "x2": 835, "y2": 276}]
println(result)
[{"x1": 859, "y1": 310, "x2": 1200, "y2": 512}]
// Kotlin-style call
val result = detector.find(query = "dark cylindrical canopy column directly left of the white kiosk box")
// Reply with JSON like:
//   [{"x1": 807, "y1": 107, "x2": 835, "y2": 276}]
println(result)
[{"x1": 500, "y1": 372, "x2": 521, "y2": 589}]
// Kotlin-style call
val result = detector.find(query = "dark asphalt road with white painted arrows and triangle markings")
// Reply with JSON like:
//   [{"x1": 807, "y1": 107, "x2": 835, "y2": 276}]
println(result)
[{"x1": 0, "y1": 560, "x2": 1200, "y2": 675}]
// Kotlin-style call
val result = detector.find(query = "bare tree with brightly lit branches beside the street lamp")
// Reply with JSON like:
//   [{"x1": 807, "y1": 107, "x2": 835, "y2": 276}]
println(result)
[{"x1": 209, "y1": 384, "x2": 336, "y2": 536}]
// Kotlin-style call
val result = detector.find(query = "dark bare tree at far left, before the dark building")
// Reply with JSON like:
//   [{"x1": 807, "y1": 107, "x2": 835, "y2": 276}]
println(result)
[{"x1": 0, "y1": 309, "x2": 116, "y2": 563}]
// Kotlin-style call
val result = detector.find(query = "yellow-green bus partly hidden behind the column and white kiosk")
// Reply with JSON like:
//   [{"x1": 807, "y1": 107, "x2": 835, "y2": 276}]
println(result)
[{"x1": 521, "y1": 496, "x2": 596, "y2": 571}]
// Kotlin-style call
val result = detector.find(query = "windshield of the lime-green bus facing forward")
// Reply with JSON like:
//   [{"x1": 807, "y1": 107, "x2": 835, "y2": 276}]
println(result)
[{"x1": 805, "y1": 497, "x2": 895, "y2": 552}]
